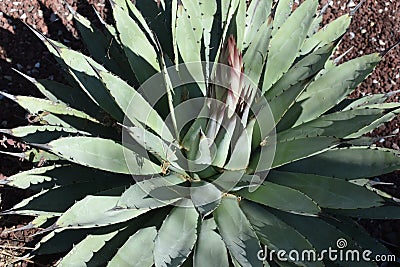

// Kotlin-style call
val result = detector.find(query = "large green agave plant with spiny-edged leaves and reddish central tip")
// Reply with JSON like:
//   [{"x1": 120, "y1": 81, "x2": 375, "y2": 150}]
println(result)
[{"x1": 1, "y1": 0, "x2": 400, "y2": 266}]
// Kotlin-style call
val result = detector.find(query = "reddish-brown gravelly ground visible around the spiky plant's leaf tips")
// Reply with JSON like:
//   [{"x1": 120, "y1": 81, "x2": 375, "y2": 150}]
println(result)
[{"x1": 0, "y1": 0, "x2": 400, "y2": 266}]
